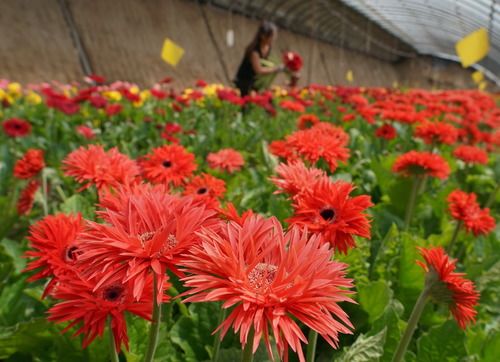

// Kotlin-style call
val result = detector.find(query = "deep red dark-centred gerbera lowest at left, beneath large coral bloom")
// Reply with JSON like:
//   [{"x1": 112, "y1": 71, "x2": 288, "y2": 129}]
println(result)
[{"x1": 48, "y1": 274, "x2": 158, "y2": 351}]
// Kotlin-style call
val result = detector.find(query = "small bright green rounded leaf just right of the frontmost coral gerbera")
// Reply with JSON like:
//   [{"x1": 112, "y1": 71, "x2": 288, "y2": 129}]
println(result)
[{"x1": 358, "y1": 280, "x2": 393, "y2": 322}]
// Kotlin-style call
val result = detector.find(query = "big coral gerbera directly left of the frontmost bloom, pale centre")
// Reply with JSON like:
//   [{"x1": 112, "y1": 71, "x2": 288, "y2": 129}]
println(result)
[{"x1": 80, "y1": 185, "x2": 219, "y2": 303}]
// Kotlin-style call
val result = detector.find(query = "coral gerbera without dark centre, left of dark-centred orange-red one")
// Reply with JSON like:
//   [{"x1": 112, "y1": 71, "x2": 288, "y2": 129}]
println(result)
[{"x1": 62, "y1": 145, "x2": 140, "y2": 190}]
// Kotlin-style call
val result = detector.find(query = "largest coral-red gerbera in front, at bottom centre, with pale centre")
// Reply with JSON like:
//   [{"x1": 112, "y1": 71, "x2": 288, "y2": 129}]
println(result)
[{"x1": 183, "y1": 216, "x2": 353, "y2": 362}]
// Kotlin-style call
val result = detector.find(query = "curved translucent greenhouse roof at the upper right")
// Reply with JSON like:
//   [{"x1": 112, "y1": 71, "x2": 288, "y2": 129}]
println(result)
[{"x1": 208, "y1": 0, "x2": 500, "y2": 84}]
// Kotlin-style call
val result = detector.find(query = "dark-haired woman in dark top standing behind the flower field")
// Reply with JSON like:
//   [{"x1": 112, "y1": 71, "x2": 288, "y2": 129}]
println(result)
[{"x1": 234, "y1": 21, "x2": 284, "y2": 97}]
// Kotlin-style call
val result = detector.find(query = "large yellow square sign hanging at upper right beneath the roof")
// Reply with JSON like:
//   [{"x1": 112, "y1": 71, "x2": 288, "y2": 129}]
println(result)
[{"x1": 455, "y1": 28, "x2": 490, "y2": 68}]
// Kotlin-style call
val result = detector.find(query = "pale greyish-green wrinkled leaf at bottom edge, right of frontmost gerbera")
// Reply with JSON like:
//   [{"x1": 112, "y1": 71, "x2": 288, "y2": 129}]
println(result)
[{"x1": 336, "y1": 328, "x2": 387, "y2": 362}]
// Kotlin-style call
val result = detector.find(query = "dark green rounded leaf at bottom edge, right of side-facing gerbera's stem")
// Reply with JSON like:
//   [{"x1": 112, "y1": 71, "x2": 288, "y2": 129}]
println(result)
[{"x1": 417, "y1": 320, "x2": 466, "y2": 362}]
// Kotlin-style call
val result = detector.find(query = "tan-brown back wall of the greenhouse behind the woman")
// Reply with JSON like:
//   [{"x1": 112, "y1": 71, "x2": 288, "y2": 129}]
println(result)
[{"x1": 0, "y1": 0, "x2": 484, "y2": 88}]
